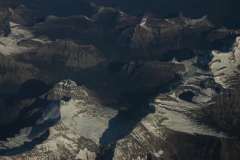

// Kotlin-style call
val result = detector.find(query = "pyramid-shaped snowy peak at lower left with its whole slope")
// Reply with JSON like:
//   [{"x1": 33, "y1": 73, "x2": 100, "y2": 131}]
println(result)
[{"x1": 1, "y1": 80, "x2": 116, "y2": 159}]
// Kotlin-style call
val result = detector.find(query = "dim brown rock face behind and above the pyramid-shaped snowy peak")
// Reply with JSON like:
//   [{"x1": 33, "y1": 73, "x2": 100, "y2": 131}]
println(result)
[{"x1": 33, "y1": 41, "x2": 103, "y2": 70}]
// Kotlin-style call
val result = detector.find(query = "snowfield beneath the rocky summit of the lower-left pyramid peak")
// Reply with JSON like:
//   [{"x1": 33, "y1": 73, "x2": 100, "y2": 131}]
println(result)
[{"x1": 0, "y1": 84, "x2": 117, "y2": 156}]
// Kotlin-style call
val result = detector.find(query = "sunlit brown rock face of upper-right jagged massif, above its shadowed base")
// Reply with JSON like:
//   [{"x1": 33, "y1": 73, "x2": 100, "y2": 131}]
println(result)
[{"x1": 131, "y1": 16, "x2": 213, "y2": 49}]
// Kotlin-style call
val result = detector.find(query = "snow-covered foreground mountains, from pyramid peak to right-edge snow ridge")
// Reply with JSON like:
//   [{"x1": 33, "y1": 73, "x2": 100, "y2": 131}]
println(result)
[{"x1": 1, "y1": 38, "x2": 240, "y2": 159}]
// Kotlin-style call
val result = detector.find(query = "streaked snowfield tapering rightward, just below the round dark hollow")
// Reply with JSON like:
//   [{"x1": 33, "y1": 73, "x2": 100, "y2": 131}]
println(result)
[{"x1": 153, "y1": 98, "x2": 225, "y2": 137}]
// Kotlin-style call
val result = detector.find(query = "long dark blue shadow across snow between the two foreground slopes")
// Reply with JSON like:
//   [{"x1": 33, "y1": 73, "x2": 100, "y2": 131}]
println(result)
[{"x1": 95, "y1": 105, "x2": 155, "y2": 160}]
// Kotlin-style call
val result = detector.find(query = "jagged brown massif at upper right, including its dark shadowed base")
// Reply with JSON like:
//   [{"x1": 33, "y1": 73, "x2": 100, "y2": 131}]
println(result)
[{"x1": 117, "y1": 14, "x2": 214, "y2": 57}]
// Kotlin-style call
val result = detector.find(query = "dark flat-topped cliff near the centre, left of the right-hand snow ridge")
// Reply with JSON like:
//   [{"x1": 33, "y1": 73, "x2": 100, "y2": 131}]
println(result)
[{"x1": 118, "y1": 61, "x2": 186, "y2": 92}]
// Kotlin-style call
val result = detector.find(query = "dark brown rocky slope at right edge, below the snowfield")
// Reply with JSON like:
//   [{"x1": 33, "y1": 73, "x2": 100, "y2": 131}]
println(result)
[{"x1": 200, "y1": 91, "x2": 240, "y2": 136}]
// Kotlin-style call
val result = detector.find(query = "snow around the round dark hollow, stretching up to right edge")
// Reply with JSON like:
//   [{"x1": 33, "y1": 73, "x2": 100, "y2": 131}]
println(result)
[{"x1": 145, "y1": 37, "x2": 240, "y2": 137}]
